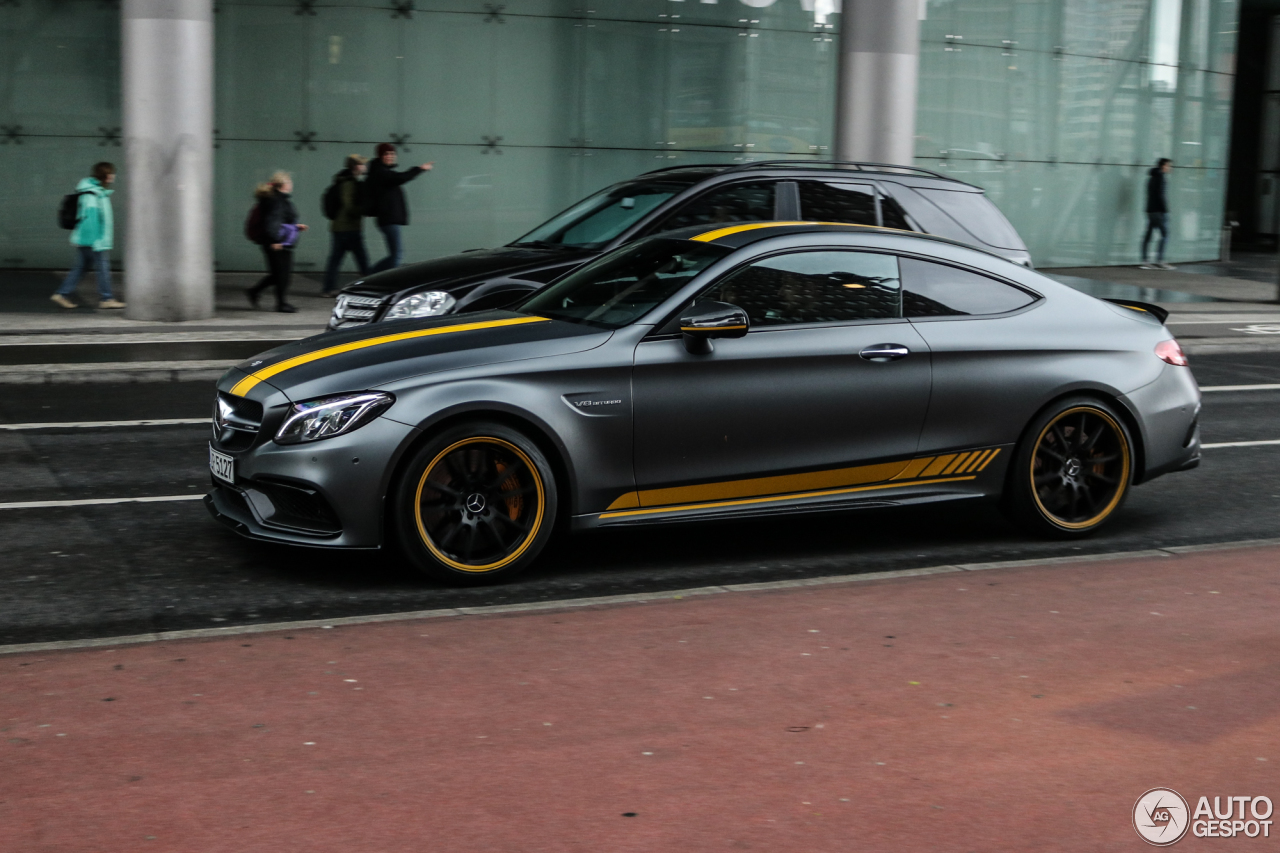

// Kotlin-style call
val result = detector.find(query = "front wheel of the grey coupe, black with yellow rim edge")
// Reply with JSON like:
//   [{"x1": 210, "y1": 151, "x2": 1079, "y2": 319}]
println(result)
[{"x1": 394, "y1": 423, "x2": 557, "y2": 585}]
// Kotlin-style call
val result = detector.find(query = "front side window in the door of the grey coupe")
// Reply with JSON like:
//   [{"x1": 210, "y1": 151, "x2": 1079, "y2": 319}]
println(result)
[{"x1": 703, "y1": 251, "x2": 902, "y2": 327}]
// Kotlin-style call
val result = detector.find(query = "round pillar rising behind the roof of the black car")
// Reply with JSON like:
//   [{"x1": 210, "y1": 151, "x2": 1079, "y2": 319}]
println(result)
[{"x1": 836, "y1": 0, "x2": 922, "y2": 165}]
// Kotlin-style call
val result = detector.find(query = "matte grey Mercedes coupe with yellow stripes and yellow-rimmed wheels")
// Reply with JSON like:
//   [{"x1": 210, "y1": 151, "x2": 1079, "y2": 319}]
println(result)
[{"x1": 206, "y1": 222, "x2": 1199, "y2": 581}]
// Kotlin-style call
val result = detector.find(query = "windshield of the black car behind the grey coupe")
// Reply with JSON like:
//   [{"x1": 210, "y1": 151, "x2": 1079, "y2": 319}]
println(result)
[{"x1": 512, "y1": 179, "x2": 690, "y2": 248}]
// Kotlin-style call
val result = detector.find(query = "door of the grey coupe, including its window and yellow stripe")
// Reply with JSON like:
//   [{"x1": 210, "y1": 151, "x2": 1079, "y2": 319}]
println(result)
[{"x1": 632, "y1": 250, "x2": 931, "y2": 506}]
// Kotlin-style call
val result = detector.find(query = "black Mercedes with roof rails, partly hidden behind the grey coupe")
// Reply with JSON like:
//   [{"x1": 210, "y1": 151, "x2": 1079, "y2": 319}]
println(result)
[{"x1": 329, "y1": 160, "x2": 1032, "y2": 330}]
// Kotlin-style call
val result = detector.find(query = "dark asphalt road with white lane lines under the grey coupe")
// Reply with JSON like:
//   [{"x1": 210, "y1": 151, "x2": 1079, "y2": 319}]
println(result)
[{"x1": 0, "y1": 353, "x2": 1280, "y2": 644}]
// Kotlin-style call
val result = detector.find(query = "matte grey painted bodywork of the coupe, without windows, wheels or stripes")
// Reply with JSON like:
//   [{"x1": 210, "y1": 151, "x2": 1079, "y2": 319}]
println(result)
[{"x1": 209, "y1": 228, "x2": 1199, "y2": 547}]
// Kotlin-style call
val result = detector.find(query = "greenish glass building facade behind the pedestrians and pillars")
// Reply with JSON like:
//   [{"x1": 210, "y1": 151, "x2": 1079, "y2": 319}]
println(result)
[{"x1": 0, "y1": 0, "x2": 1236, "y2": 272}]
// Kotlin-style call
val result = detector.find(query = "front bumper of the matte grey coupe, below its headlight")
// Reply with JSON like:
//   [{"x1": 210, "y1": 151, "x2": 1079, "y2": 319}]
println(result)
[{"x1": 205, "y1": 418, "x2": 419, "y2": 548}]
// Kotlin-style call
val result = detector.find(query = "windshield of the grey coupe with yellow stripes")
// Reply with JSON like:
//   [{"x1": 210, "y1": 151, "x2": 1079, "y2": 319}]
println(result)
[{"x1": 518, "y1": 237, "x2": 732, "y2": 329}]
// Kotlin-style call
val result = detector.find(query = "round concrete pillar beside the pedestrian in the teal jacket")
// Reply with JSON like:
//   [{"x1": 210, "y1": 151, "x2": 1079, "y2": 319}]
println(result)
[{"x1": 119, "y1": 0, "x2": 214, "y2": 321}]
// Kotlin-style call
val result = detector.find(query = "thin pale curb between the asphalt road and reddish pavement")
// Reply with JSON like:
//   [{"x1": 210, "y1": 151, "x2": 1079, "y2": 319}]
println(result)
[{"x1": 0, "y1": 539, "x2": 1280, "y2": 654}]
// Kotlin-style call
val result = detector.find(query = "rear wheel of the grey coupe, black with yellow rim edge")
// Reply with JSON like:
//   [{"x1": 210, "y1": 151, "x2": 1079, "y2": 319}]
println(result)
[{"x1": 1002, "y1": 397, "x2": 1134, "y2": 539}]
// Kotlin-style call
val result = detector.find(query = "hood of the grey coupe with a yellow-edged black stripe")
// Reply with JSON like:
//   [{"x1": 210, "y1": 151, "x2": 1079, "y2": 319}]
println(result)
[{"x1": 218, "y1": 311, "x2": 613, "y2": 406}]
